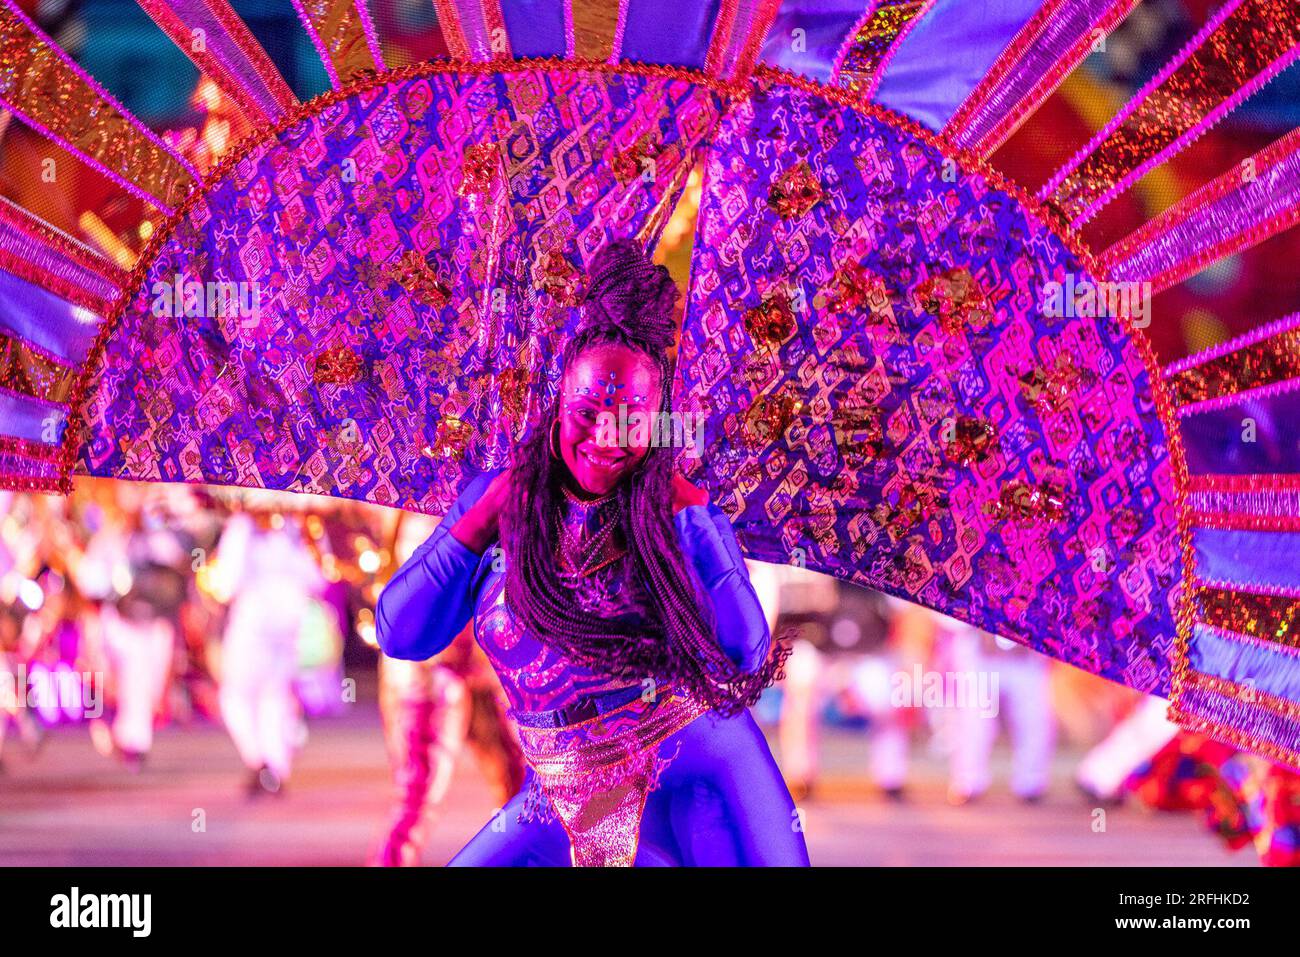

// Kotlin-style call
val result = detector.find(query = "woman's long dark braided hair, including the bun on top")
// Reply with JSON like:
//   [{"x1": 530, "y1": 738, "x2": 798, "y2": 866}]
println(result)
[{"x1": 502, "y1": 239, "x2": 780, "y2": 714}]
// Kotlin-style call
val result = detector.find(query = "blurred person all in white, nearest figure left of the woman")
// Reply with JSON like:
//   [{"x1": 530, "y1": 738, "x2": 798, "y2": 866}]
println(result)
[{"x1": 216, "y1": 512, "x2": 325, "y2": 797}]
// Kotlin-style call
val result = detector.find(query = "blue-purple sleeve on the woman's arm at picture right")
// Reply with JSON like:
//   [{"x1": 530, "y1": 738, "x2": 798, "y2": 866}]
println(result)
[{"x1": 673, "y1": 505, "x2": 772, "y2": 671}]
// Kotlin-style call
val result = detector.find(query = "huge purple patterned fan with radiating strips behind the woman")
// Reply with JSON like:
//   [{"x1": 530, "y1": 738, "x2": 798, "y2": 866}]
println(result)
[{"x1": 0, "y1": 0, "x2": 1300, "y2": 765}]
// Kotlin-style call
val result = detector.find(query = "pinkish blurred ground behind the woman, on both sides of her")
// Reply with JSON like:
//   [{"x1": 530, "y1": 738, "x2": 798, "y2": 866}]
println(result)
[{"x1": 0, "y1": 703, "x2": 1257, "y2": 866}]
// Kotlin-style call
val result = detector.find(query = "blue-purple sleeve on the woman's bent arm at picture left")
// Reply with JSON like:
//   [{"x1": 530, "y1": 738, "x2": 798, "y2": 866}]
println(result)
[{"x1": 376, "y1": 472, "x2": 495, "y2": 661}]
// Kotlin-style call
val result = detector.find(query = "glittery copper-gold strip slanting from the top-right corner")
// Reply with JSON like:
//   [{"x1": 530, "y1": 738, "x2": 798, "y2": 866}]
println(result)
[{"x1": 1043, "y1": 0, "x2": 1300, "y2": 218}]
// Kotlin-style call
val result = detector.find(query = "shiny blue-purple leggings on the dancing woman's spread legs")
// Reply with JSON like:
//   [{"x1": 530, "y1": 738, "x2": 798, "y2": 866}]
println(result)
[{"x1": 450, "y1": 711, "x2": 809, "y2": 867}]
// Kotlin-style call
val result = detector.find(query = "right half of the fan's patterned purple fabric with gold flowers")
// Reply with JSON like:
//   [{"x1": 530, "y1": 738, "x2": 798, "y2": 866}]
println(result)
[{"x1": 675, "y1": 85, "x2": 1180, "y2": 693}]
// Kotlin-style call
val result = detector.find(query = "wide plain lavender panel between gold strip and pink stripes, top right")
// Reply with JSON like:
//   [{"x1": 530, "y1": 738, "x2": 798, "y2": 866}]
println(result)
[{"x1": 875, "y1": 0, "x2": 1043, "y2": 130}]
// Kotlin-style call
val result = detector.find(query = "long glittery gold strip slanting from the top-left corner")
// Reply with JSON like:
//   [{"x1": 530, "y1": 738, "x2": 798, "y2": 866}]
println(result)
[{"x1": 0, "y1": 7, "x2": 192, "y2": 207}]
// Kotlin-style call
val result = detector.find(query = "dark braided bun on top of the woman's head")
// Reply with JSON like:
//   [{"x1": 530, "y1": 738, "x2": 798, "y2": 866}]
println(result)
[{"x1": 577, "y1": 239, "x2": 677, "y2": 350}]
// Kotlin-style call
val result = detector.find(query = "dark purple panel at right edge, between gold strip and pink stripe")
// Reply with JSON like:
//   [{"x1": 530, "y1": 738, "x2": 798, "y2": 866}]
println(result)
[{"x1": 1179, "y1": 390, "x2": 1300, "y2": 475}]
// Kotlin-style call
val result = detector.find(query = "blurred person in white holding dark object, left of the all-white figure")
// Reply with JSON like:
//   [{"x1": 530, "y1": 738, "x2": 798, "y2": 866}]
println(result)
[{"x1": 74, "y1": 485, "x2": 192, "y2": 771}]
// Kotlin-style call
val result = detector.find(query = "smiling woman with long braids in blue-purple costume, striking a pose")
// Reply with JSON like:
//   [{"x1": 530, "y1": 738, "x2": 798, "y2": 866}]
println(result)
[{"x1": 377, "y1": 241, "x2": 807, "y2": 866}]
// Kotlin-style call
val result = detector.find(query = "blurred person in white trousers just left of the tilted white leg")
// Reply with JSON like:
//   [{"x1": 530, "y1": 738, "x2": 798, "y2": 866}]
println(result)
[{"x1": 939, "y1": 615, "x2": 1056, "y2": 805}]
